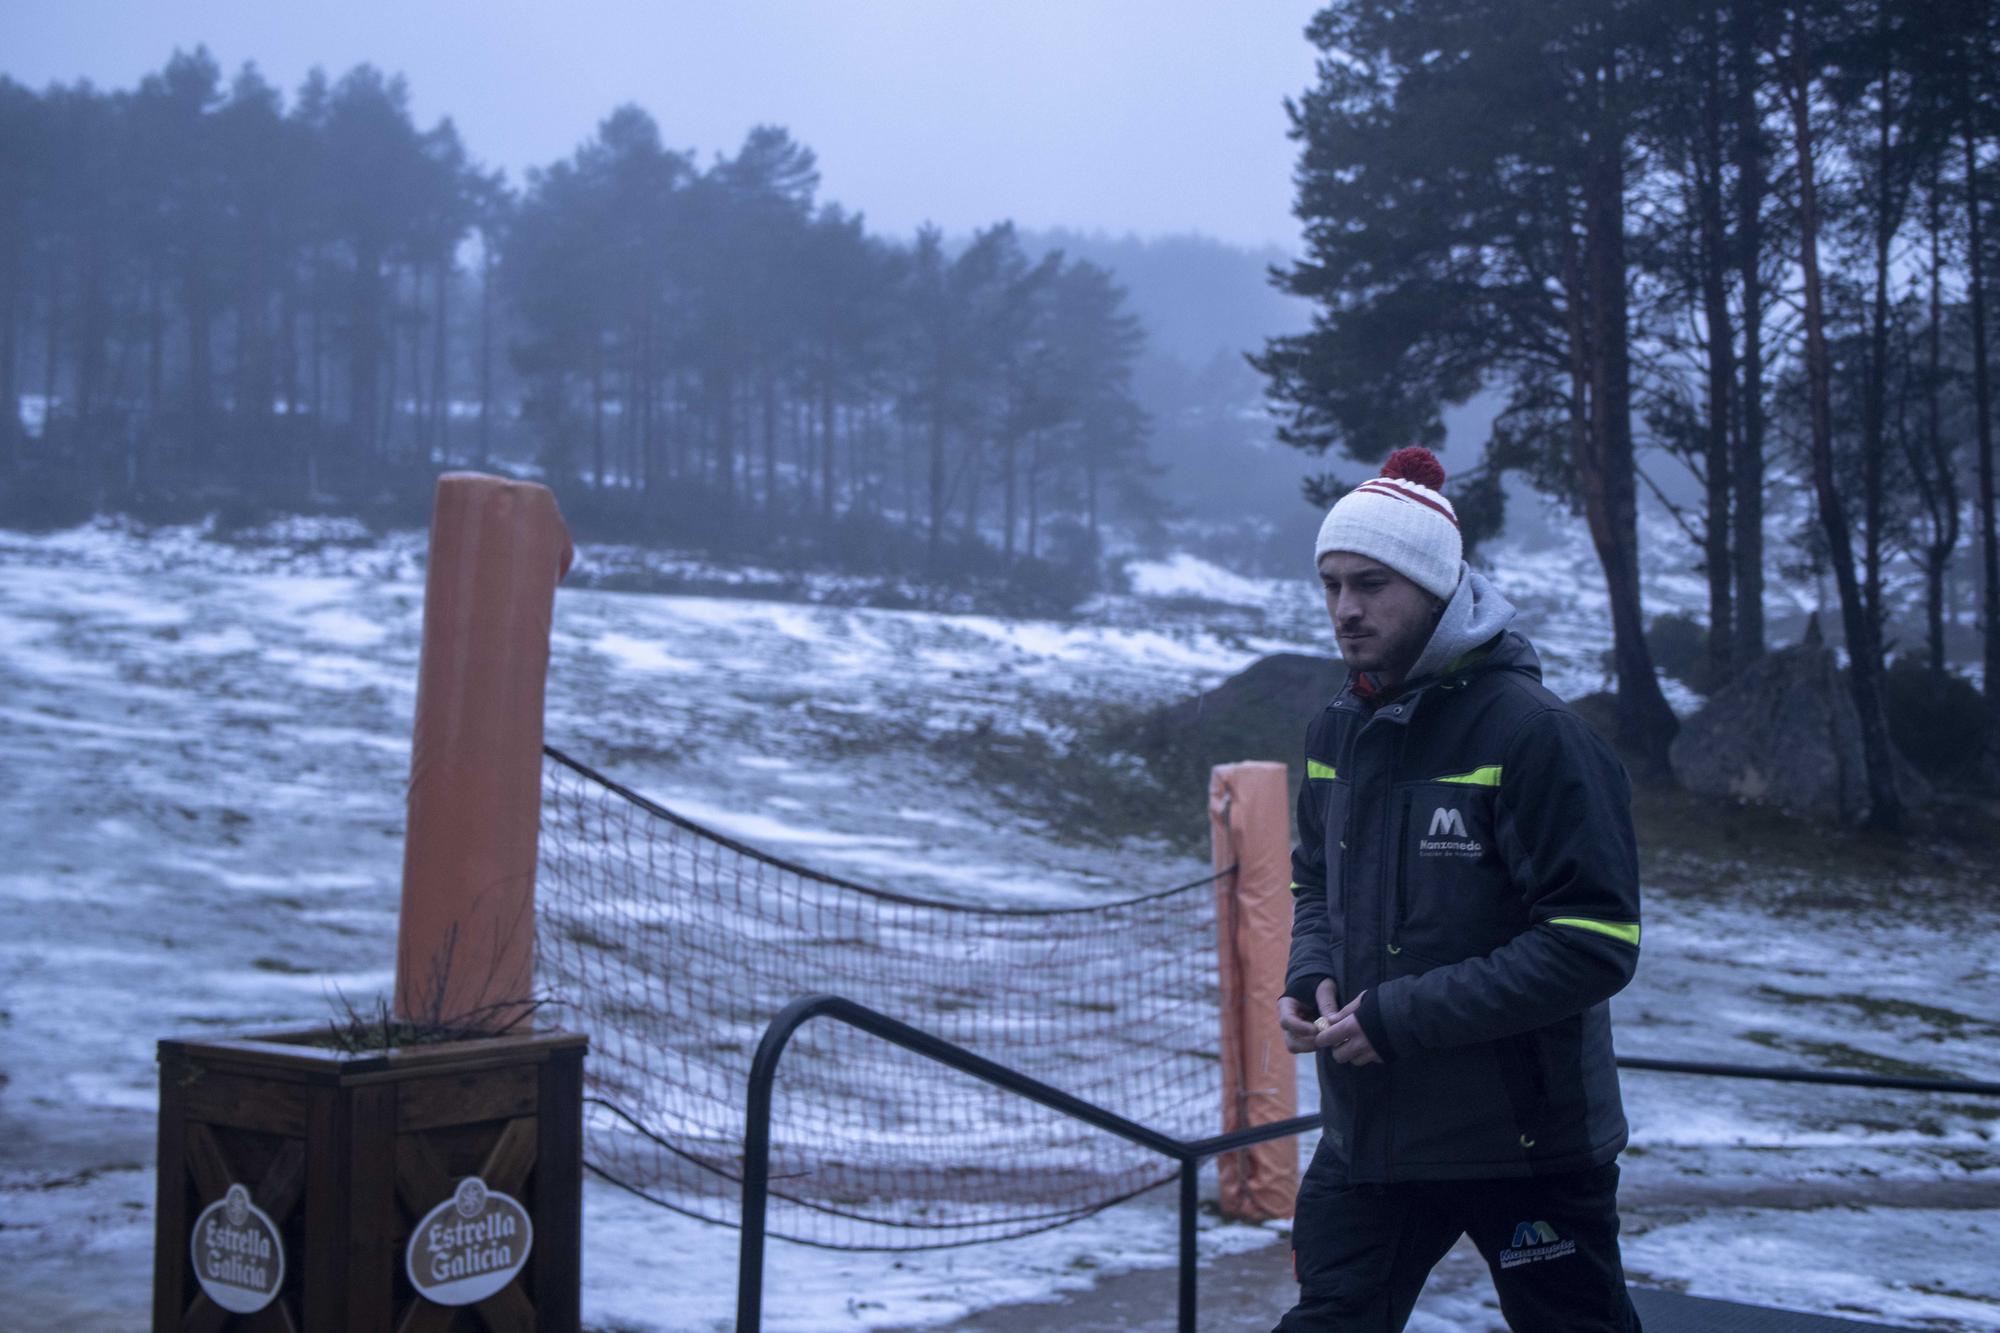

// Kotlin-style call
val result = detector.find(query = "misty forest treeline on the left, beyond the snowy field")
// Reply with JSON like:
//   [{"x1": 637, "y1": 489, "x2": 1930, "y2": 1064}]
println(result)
[{"x1": 0, "y1": 50, "x2": 1156, "y2": 592}]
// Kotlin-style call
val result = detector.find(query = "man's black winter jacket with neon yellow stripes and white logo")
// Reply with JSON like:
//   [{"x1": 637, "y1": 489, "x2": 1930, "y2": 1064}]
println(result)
[{"x1": 1286, "y1": 630, "x2": 1640, "y2": 1185}]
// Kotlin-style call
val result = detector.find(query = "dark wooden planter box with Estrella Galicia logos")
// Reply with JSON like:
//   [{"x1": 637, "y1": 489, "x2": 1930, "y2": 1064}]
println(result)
[{"x1": 152, "y1": 1029, "x2": 586, "y2": 1333}]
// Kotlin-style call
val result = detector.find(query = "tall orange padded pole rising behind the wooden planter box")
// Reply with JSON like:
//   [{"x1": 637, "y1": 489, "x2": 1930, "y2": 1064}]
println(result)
[{"x1": 396, "y1": 472, "x2": 572, "y2": 1029}]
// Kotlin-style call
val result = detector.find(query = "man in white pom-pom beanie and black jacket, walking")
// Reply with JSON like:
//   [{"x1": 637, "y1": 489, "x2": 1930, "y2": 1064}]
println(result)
[{"x1": 1278, "y1": 448, "x2": 1640, "y2": 1333}]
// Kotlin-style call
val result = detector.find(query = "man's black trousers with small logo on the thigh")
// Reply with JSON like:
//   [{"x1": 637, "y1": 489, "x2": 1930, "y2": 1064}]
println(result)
[{"x1": 1272, "y1": 1147, "x2": 1640, "y2": 1333}]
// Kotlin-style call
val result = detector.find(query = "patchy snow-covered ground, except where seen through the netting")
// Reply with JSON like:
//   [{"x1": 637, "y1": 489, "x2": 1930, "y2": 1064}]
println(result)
[{"x1": 0, "y1": 510, "x2": 2000, "y2": 1331}]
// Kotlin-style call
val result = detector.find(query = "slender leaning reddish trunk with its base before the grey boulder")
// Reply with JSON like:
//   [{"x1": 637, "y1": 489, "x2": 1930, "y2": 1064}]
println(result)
[{"x1": 1786, "y1": 8, "x2": 1904, "y2": 831}]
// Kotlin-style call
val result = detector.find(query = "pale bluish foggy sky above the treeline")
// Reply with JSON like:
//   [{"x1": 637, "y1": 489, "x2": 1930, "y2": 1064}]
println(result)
[{"x1": 0, "y1": 0, "x2": 1316, "y2": 250}]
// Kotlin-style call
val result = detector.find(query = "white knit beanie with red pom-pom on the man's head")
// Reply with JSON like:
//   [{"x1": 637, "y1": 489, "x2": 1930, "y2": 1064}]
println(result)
[{"x1": 1312, "y1": 448, "x2": 1464, "y2": 598}]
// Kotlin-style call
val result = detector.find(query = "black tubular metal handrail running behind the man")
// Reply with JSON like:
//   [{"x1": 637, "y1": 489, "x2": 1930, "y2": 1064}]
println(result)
[{"x1": 736, "y1": 995, "x2": 2000, "y2": 1333}]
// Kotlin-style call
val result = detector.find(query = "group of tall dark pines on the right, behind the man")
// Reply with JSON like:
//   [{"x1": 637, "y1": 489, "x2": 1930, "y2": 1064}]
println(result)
[{"x1": 1258, "y1": 0, "x2": 2000, "y2": 827}]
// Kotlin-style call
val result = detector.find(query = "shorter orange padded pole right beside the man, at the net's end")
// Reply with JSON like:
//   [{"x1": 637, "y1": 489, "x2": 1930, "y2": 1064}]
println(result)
[{"x1": 1208, "y1": 763, "x2": 1298, "y2": 1221}]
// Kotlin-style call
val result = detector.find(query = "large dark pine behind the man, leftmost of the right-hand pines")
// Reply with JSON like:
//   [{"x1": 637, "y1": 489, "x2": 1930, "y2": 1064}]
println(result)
[{"x1": 1256, "y1": 0, "x2": 1676, "y2": 769}]
